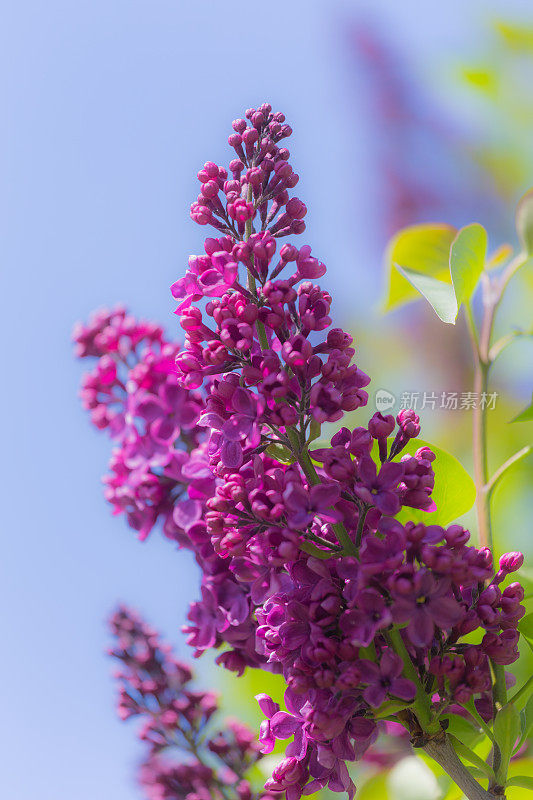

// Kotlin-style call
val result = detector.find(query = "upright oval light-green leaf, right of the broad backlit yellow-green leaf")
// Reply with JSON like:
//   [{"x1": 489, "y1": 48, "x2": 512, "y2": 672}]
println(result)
[{"x1": 450, "y1": 222, "x2": 487, "y2": 308}]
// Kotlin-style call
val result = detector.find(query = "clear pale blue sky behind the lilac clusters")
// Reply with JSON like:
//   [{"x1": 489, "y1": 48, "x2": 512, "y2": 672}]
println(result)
[{"x1": 0, "y1": 0, "x2": 528, "y2": 800}]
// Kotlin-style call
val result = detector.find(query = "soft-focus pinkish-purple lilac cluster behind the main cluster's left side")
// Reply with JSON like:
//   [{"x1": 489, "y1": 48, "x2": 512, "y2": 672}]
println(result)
[{"x1": 73, "y1": 308, "x2": 262, "y2": 672}]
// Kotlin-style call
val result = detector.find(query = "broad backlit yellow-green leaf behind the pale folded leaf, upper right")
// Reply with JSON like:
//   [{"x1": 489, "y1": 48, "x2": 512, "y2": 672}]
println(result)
[{"x1": 384, "y1": 225, "x2": 457, "y2": 311}]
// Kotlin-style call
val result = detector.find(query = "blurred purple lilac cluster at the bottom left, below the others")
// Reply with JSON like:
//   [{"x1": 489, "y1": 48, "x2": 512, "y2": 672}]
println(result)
[{"x1": 110, "y1": 607, "x2": 274, "y2": 800}]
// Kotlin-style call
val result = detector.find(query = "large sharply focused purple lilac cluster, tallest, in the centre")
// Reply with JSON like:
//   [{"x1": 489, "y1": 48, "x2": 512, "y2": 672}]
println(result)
[{"x1": 77, "y1": 105, "x2": 524, "y2": 800}]
